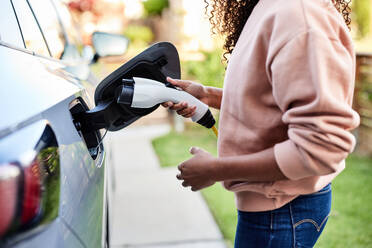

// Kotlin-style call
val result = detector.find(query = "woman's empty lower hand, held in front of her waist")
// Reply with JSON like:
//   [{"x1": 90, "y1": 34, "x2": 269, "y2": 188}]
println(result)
[{"x1": 177, "y1": 147, "x2": 216, "y2": 191}]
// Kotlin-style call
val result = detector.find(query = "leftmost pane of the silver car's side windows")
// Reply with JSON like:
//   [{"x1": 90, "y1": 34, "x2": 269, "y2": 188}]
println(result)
[{"x1": 0, "y1": 1, "x2": 23, "y2": 47}]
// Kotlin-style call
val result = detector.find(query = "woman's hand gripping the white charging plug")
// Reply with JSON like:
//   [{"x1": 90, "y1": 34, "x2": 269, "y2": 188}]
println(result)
[{"x1": 162, "y1": 77, "x2": 208, "y2": 118}]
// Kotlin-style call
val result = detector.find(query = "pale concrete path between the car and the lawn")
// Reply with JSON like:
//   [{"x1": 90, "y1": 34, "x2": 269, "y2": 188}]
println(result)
[{"x1": 108, "y1": 125, "x2": 226, "y2": 248}]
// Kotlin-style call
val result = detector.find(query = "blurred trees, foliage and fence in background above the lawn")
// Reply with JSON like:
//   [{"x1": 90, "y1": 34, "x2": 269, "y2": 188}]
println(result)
[{"x1": 65, "y1": 0, "x2": 372, "y2": 156}]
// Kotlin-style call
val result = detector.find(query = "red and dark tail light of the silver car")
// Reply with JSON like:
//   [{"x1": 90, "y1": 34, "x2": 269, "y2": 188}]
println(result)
[{"x1": 0, "y1": 122, "x2": 60, "y2": 240}]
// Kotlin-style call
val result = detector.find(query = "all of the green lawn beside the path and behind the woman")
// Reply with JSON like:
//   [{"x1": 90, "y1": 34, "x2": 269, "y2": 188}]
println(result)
[{"x1": 153, "y1": 124, "x2": 372, "y2": 248}]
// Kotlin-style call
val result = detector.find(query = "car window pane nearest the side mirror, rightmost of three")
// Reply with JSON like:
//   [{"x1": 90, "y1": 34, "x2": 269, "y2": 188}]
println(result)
[{"x1": 28, "y1": 0, "x2": 66, "y2": 59}]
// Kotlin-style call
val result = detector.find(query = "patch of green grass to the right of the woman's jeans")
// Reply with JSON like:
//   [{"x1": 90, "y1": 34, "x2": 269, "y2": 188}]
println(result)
[{"x1": 317, "y1": 156, "x2": 372, "y2": 247}]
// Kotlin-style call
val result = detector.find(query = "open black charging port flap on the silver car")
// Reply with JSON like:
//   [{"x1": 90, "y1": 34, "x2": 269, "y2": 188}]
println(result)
[{"x1": 73, "y1": 42, "x2": 181, "y2": 133}]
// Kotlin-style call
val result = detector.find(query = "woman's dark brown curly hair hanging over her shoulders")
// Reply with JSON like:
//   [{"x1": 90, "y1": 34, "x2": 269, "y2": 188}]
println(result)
[{"x1": 204, "y1": 0, "x2": 351, "y2": 62}]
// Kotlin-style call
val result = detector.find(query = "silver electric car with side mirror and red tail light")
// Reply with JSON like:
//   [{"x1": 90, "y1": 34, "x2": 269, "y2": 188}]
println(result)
[{"x1": 0, "y1": 0, "x2": 128, "y2": 247}]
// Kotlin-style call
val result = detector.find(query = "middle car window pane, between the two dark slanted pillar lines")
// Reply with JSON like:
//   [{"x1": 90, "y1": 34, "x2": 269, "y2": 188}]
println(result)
[{"x1": 12, "y1": 0, "x2": 50, "y2": 57}]
